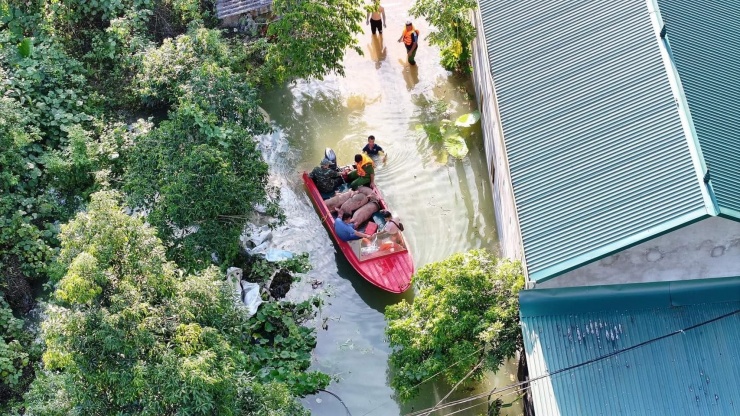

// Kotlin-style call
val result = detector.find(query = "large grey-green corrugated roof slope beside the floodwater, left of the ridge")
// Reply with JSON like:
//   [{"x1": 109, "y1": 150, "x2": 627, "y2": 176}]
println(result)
[{"x1": 479, "y1": 0, "x2": 707, "y2": 281}]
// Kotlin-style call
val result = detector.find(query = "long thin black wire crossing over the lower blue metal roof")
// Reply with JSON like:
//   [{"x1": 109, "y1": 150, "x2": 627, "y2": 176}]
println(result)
[{"x1": 406, "y1": 309, "x2": 740, "y2": 416}]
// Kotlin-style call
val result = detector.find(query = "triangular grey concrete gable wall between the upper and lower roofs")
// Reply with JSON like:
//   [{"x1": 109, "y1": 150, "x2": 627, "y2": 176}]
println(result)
[{"x1": 537, "y1": 217, "x2": 740, "y2": 289}]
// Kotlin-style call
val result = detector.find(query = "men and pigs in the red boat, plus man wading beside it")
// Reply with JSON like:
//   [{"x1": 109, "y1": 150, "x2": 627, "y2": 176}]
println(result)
[{"x1": 309, "y1": 135, "x2": 402, "y2": 244}]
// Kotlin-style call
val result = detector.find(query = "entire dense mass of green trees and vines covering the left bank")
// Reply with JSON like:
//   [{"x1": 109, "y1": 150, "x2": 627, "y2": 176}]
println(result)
[{"x1": 0, "y1": 0, "x2": 362, "y2": 415}]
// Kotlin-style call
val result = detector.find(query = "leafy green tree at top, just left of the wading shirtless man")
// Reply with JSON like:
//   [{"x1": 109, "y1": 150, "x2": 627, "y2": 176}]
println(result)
[{"x1": 266, "y1": 0, "x2": 364, "y2": 82}]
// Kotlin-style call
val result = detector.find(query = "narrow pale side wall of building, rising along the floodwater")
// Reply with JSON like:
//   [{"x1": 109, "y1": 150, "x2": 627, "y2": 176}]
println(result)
[{"x1": 473, "y1": 8, "x2": 524, "y2": 268}]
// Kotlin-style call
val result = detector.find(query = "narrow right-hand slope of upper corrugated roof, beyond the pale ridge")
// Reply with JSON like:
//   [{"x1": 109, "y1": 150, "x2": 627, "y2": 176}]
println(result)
[{"x1": 658, "y1": 0, "x2": 740, "y2": 220}]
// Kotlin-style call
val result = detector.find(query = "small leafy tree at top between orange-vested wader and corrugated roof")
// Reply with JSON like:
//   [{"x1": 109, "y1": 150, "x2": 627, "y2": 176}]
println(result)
[{"x1": 409, "y1": 0, "x2": 478, "y2": 73}]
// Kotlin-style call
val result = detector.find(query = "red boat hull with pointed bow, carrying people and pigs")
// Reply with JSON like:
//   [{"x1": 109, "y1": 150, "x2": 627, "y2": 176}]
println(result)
[{"x1": 303, "y1": 172, "x2": 414, "y2": 293}]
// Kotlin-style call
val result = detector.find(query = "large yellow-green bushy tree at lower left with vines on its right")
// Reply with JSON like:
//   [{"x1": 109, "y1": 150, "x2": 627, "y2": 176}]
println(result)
[{"x1": 26, "y1": 192, "x2": 329, "y2": 415}]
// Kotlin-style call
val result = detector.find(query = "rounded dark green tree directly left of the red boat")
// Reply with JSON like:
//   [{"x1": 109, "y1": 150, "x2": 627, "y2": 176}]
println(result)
[{"x1": 125, "y1": 103, "x2": 268, "y2": 266}]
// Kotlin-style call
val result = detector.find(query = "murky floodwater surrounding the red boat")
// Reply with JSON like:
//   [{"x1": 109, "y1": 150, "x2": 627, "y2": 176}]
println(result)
[{"x1": 261, "y1": 0, "x2": 521, "y2": 416}]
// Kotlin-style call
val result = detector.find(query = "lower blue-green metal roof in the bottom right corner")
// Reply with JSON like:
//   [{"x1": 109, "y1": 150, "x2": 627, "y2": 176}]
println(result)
[{"x1": 520, "y1": 278, "x2": 740, "y2": 416}]
